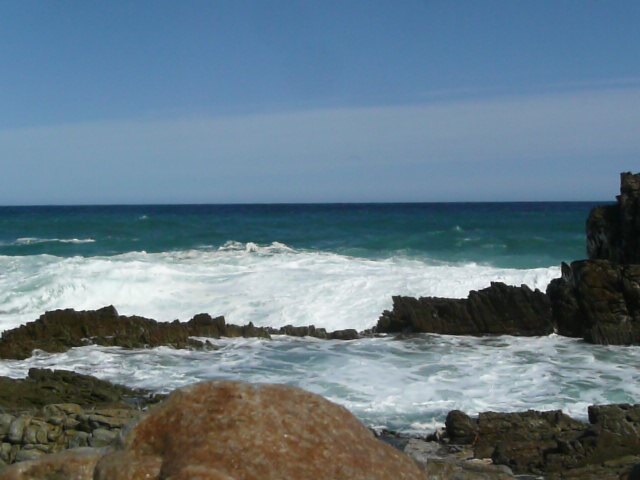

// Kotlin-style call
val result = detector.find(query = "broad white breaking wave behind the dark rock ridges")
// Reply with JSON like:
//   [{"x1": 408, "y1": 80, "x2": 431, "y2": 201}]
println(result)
[{"x1": 0, "y1": 243, "x2": 559, "y2": 330}]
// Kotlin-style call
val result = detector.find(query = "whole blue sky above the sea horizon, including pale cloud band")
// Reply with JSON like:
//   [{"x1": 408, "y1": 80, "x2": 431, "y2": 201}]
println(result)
[{"x1": 0, "y1": 0, "x2": 640, "y2": 205}]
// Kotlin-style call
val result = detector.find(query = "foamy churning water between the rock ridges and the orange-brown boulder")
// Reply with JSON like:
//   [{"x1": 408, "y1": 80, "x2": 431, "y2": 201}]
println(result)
[{"x1": 0, "y1": 335, "x2": 640, "y2": 431}]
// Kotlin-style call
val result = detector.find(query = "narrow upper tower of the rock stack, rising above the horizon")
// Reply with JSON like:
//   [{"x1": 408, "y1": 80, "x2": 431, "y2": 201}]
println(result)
[{"x1": 587, "y1": 172, "x2": 640, "y2": 264}]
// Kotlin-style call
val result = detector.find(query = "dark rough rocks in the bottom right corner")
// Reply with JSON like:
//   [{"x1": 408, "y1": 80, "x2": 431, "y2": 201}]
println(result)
[{"x1": 446, "y1": 405, "x2": 640, "y2": 479}]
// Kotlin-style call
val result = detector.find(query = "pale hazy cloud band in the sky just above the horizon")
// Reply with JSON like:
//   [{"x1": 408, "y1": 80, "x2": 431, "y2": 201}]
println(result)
[{"x1": 0, "y1": 88, "x2": 640, "y2": 203}]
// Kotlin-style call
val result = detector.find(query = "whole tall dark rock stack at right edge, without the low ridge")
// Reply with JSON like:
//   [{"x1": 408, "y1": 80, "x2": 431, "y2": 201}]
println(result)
[{"x1": 547, "y1": 173, "x2": 640, "y2": 345}]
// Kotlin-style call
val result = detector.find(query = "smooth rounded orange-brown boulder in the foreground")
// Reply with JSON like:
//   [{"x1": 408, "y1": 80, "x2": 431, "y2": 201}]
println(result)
[{"x1": 0, "y1": 382, "x2": 423, "y2": 480}]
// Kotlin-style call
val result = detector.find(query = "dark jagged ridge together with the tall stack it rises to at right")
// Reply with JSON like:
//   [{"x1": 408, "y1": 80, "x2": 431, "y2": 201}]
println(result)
[{"x1": 376, "y1": 173, "x2": 640, "y2": 345}]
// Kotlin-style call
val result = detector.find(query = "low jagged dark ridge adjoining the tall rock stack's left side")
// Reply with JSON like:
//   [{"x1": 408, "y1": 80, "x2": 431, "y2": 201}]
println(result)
[{"x1": 375, "y1": 282, "x2": 553, "y2": 336}]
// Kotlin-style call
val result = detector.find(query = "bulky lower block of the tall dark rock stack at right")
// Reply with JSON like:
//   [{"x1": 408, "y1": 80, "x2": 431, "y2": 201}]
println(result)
[{"x1": 547, "y1": 260, "x2": 640, "y2": 345}]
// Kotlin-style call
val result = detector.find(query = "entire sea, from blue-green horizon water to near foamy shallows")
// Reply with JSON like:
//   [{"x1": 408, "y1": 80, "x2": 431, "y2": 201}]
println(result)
[{"x1": 0, "y1": 202, "x2": 640, "y2": 433}]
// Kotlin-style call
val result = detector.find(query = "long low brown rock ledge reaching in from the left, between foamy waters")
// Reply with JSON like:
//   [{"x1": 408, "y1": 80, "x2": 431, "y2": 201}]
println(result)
[{"x1": 0, "y1": 306, "x2": 359, "y2": 360}]
